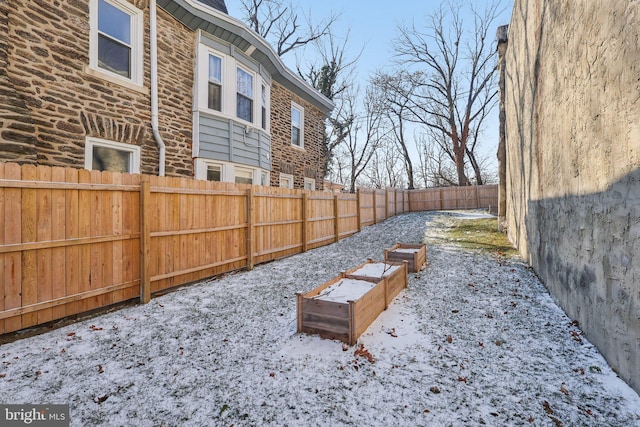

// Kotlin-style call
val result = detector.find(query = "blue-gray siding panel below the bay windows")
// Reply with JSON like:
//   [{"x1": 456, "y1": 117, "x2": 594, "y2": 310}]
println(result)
[{"x1": 198, "y1": 113, "x2": 271, "y2": 170}]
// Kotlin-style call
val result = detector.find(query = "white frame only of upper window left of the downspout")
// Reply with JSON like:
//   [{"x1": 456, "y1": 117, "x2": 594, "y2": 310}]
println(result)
[{"x1": 89, "y1": 0, "x2": 144, "y2": 87}]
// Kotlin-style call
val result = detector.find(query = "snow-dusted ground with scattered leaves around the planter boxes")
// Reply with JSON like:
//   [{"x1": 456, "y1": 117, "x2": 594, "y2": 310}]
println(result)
[{"x1": 0, "y1": 212, "x2": 640, "y2": 426}]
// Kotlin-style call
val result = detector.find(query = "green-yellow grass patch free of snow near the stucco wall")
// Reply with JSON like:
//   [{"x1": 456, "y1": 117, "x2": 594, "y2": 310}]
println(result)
[{"x1": 445, "y1": 218, "x2": 518, "y2": 256}]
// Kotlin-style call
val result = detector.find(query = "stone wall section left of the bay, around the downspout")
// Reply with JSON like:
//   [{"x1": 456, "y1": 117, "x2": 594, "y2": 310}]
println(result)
[{"x1": 0, "y1": 0, "x2": 194, "y2": 176}]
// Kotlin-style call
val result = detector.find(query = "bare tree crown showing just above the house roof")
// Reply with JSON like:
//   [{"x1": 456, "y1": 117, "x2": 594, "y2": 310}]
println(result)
[{"x1": 240, "y1": 0, "x2": 338, "y2": 56}]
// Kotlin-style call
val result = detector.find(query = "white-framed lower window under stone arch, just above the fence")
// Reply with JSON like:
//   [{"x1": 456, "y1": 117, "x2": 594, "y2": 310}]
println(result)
[{"x1": 84, "y1": 138, "x2": 140, "y2": 173}]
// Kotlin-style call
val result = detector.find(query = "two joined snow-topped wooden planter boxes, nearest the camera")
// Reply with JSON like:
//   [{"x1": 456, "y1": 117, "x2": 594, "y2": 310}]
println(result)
[{"x1": 296, "y1": 261, "x2": 407, "y2": 345}]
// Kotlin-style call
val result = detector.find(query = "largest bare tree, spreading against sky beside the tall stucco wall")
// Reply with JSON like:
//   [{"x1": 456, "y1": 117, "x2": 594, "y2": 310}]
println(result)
[{"x1": 394, "y1": 0, "x2": 500, "y2": 185}]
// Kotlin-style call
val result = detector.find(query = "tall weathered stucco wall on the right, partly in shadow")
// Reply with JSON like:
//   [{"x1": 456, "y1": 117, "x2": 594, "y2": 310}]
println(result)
[{"x1": 505, "y1": 0, "x2": 640, "y2": 392}]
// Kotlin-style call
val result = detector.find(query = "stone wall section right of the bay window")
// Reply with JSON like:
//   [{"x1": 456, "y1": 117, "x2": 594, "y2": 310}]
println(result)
[{"x1": 271, "y1": 82, "x2": 324, "y2": 190}]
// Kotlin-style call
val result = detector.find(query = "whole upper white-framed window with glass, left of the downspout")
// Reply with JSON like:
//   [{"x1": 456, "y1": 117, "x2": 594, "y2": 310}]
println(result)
[{"x1": 89, "y1": 0, "x2": 143, "y2": 85}]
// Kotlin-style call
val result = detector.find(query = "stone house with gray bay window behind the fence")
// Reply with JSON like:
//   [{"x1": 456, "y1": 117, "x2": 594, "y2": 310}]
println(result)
[{"x1": 0, "y1": 0, "x2": 333, "y2": 189}]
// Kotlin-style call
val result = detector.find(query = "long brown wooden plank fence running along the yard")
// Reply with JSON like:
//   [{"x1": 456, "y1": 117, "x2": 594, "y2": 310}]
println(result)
[{"x1": 0, "y1": 162, "x2": 497, "y2": 333}]
